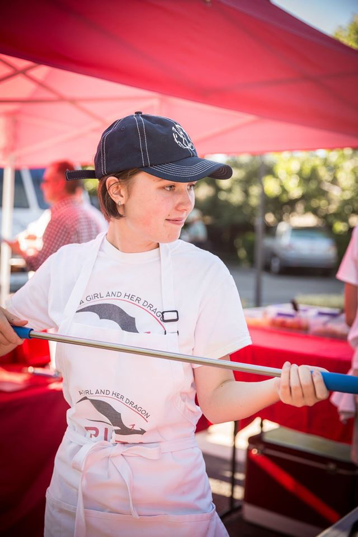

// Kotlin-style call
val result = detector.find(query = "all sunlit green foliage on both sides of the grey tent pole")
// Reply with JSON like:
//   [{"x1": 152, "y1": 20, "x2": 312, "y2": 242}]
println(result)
[{"x1": 196, "y1": 149, "x2": 358, "y2": 264}]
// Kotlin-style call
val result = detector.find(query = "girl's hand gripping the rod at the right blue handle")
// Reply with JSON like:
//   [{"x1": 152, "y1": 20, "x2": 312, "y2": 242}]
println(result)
[{"x1": 278, "y1": 362, "x2": 329, "y2": 407}]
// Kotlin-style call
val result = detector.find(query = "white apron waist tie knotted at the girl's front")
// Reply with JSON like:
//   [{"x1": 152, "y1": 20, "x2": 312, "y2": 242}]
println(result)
[{"x1": 65, "y1": 428, "x2": 197, "y2": 537}]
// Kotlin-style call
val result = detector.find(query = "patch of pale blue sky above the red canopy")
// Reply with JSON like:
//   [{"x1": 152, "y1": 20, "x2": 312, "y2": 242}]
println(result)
[{"x1": 271, "y1": 0, "x2": 358, "y2": 35}]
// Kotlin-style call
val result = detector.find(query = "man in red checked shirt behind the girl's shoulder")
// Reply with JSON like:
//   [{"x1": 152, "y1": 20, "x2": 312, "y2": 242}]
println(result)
[{"x1": 6, "y1": 160, "x2": 108, "y2": 271}]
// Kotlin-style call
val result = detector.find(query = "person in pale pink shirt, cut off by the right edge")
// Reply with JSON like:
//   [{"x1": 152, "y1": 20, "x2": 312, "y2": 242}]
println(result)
[{"x1": 331, "y1": 226, "x2": 358, "y2": 464}]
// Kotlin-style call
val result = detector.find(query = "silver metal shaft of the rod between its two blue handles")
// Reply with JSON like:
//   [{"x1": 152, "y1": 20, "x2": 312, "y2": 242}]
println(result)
[{"x1": 29, "y1": 330, "x2": 281, "y2": 377}]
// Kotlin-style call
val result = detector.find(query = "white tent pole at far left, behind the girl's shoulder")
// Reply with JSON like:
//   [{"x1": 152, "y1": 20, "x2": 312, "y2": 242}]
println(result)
[{"x1": 0, "y1": 157, "x2": 15, "y2": 307}]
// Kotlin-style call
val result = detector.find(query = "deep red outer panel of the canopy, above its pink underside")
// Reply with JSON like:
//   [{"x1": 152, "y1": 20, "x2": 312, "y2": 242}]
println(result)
[{"x1": 0, "y1": 0, "x2": 358, "y2": 151}]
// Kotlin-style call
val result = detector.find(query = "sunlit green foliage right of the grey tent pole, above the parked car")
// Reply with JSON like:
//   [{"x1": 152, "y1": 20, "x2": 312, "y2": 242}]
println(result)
[{"x1": 264, "y1": 149, "x2": 358, "y2": 230}]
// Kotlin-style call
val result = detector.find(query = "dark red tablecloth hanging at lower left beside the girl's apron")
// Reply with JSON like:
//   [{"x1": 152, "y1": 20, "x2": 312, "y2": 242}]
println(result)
[{"x1": 0, "y1": 370, "x2": 68, "y2": 537}]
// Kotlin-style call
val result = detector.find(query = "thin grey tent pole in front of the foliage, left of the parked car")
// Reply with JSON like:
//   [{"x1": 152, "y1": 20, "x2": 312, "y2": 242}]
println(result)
[{"x1": 255, "y1": 155, "x2": 265, "y2": 307}]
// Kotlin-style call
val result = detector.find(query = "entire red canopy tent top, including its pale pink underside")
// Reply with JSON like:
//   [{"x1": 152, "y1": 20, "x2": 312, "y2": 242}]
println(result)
[{"x1": 0, "y1": 0, "x2": 358, "y2": 304}]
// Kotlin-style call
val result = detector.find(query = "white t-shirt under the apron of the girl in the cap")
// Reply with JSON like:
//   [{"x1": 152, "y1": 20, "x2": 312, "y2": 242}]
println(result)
[{"x1": 7, "y1": 239, "x2": 251, "y2": 358}]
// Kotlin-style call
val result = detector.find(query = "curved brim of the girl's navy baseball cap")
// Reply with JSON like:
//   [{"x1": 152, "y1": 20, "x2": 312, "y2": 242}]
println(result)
[{"x1": 141, "y1": 157, "x2": 232, "y2": 183}]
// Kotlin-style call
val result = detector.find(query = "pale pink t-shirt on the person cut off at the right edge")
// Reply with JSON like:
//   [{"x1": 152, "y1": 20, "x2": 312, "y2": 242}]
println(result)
[{"x1": 337, "y1": 226, "x2": 358, "y2": 348}]
